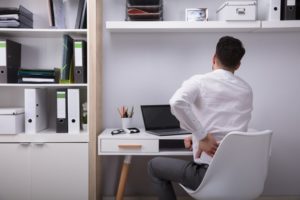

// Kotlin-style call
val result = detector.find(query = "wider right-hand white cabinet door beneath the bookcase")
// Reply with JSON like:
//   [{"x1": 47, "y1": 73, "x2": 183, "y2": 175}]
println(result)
[{"x1": 31, "y1": 143, "x2": 88, "y2": 200}]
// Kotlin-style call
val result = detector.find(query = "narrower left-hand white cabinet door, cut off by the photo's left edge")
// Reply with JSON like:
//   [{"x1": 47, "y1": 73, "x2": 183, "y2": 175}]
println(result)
[{"x1": 0, "y1": 143, "x2": 30, "y2": 200}]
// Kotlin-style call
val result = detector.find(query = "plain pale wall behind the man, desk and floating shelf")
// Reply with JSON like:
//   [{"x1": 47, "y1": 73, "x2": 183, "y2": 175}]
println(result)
[{"x1": 102, "y1": 0, "x2": 300, "y2": 196}]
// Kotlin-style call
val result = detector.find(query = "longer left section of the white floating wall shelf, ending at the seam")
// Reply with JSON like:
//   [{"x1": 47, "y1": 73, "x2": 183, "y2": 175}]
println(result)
[{"x1": 106, "y1": 21, "x2": 261, "y2": 32}]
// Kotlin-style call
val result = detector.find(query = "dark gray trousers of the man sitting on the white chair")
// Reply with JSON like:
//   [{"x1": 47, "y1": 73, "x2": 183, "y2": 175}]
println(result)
[{"x1": 148, "y1": 157, "x2": 208, "y2": 200}]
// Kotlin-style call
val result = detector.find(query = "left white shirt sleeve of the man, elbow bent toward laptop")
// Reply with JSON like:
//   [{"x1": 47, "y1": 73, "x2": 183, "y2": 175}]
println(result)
[{"x1": 169, "y1": 77, "x2": 207, "y2": 140}]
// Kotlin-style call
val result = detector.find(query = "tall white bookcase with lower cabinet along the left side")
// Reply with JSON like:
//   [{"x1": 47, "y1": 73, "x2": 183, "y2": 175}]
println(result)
[{"x1": 0, "y1": 0, "x2": 96, "y2": 200}]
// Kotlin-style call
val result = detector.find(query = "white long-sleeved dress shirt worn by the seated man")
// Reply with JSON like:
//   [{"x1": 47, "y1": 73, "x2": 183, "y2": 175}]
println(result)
[{"x1": 170, "y1": 69, "x2": 253, "y2": 164}]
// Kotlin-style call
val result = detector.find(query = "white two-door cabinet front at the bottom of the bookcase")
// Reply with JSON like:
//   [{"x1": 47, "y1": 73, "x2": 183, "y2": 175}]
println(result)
[{"x1": 0, "y1": 143, "x2": 88, "y2": 200}]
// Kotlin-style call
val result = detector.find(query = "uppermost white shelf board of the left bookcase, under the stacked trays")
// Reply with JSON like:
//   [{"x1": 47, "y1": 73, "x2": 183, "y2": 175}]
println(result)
[{"x1": 0, "y1": 28, "x2": 87, "y2": 38}]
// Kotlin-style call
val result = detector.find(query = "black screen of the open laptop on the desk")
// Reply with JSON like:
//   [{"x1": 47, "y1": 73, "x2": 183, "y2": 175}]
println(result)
[{"x1": 141, "y1": 105, "x2": 180, "y2": 130}]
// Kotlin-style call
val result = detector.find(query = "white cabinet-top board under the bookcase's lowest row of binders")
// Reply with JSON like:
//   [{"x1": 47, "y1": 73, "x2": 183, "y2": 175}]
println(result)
[{"x1": 0, "y1": 130, "x2": 89, "y2": 143}]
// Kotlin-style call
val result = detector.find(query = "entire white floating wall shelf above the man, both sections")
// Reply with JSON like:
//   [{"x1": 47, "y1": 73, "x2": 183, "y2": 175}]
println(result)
[{"x1": 106, "y1": 20, "x2": 300, "y2": 33}]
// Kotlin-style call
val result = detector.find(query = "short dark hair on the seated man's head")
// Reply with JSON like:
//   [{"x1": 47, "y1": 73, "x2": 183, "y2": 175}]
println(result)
[{"x1": 216, "y1": 36, "x2": 245, "y2": 69}]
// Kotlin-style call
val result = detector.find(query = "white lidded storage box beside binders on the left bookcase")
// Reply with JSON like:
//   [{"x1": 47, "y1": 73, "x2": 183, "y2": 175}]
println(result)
[{"x1": 0, "y1": 108, "x2": 25, "y2": 134}]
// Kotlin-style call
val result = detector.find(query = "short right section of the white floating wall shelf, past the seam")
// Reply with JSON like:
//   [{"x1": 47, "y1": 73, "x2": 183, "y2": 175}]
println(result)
[{"x1": 261, "y1": 20, "x2": 300, "y2": 32}]
